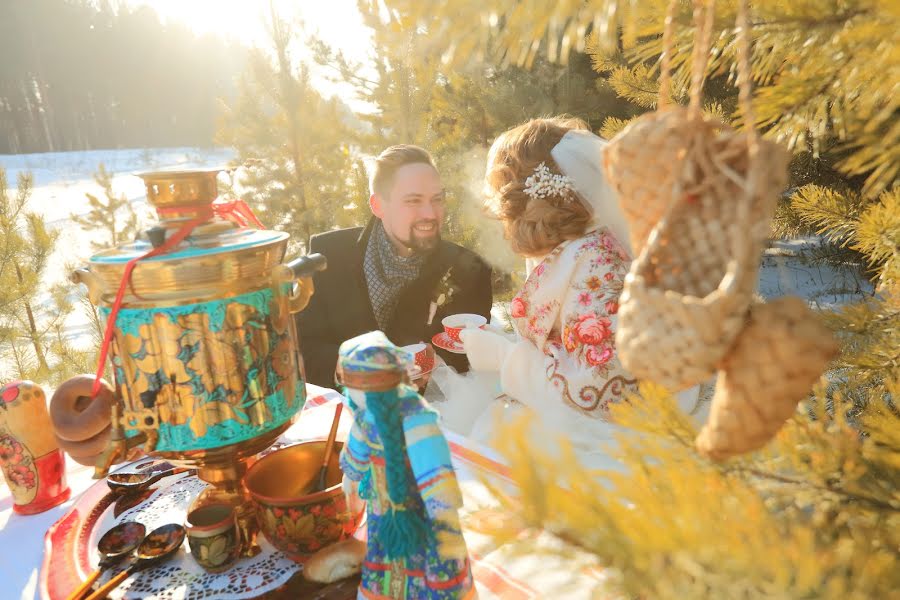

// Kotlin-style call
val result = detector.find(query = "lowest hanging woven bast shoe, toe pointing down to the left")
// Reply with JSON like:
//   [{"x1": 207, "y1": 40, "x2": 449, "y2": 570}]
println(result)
[{"x1": 695, "y1": 297, "x2": 838, "y2": 460}]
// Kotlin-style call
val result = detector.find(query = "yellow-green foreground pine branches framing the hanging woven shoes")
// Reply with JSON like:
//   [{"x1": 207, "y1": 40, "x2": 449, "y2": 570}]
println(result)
[{"x1": 386, "y1": 0, "x2": 900, "y2": 599}]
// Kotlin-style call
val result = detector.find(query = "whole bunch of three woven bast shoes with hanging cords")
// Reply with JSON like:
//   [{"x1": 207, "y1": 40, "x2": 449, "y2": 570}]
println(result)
[{"x1": 605, "y1": 0, "x2": 834, "y2": 458}]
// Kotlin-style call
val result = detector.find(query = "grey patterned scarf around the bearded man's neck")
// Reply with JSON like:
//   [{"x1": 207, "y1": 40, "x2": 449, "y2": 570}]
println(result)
[{"x1": 363, "y1": 219, "x2": 426, "y2": 331}]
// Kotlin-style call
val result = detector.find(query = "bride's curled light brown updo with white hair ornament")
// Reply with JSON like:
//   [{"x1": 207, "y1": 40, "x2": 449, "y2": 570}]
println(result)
[{"x1": 485, "y1": 117, "x2": 591, "y2": 256}]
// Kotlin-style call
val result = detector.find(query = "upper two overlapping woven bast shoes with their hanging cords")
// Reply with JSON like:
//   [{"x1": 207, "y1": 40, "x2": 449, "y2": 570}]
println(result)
[{"x1": 606, "y1": 1, "x2": 788, "y2": 391}]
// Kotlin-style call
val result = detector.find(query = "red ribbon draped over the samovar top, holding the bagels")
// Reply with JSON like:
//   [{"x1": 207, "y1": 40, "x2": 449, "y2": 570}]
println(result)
[{"x1": 91, "y1": 200, "x2": 265, "y2": 398}]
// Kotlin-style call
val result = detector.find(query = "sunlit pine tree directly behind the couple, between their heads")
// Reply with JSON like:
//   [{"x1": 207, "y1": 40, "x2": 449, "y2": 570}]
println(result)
[{"x1": 312, "y1": 8, "x2": 633, "y2": 298}]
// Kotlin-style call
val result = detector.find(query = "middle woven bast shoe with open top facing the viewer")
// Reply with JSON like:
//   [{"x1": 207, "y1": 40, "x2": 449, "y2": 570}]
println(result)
[{"x1": 616, "y1": 108, "x2": 788, "y2": 391}]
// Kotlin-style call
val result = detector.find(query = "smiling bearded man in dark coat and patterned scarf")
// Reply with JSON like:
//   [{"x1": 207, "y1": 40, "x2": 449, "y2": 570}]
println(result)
[{"x1": 297, "y1": 145, "x2": 492, "y2": 387}]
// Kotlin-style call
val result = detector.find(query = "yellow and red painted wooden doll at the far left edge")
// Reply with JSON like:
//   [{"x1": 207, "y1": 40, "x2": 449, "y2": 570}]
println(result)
[{"x1": 0, "y1": 381, "x2": 71, "y2": 515}]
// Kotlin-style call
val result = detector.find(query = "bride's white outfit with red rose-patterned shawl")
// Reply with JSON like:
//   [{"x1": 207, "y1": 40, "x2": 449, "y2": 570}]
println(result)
[{"x1": 432, "y1": 227, "x2": 712, "y2": 469}]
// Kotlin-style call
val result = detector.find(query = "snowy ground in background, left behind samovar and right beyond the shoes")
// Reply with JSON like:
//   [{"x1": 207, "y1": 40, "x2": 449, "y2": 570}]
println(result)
[{"x1": 0, "y1": 148, "x2": 871, "y2": 378}]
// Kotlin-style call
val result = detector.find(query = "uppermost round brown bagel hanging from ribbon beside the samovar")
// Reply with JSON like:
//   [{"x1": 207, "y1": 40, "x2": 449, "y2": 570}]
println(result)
[{"x1": 50, "y1": 375, "x2": 116, "y2": 442}]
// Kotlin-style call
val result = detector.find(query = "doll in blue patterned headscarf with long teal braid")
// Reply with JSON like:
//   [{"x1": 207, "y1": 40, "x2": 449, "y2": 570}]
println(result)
[{"x1": 338, "y1": 331, "x2": 475, "y2": 600}]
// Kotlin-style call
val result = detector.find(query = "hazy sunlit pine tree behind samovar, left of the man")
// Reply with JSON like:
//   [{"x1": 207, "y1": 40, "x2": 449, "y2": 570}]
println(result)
[{"x1": 218, "y1": 2, "x2": 357, "y2": 249}]
